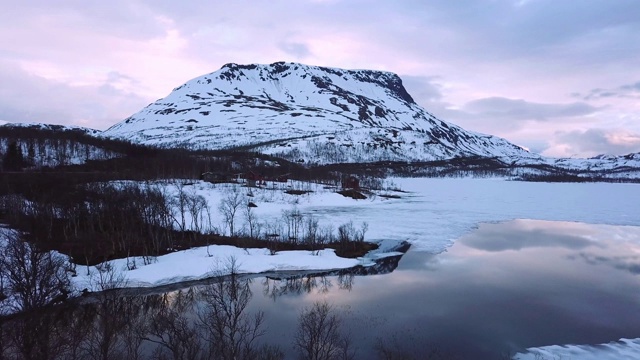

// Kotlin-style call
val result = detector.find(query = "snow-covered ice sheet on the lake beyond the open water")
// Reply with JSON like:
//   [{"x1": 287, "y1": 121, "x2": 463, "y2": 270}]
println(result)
[{"x1": 298, "y1": 178, "x2": 640, "y2": 253}]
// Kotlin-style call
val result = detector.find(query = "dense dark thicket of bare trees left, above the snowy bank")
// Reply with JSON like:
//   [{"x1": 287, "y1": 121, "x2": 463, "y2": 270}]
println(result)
[{"x1": 0, "y1": 183, "x2": 180, "y2": 265}]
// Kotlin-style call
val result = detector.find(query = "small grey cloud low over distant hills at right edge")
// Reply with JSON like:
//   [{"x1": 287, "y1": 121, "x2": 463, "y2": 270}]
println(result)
[{"x1": 556, "y1": 129, "x2": 640, "y2": 155}]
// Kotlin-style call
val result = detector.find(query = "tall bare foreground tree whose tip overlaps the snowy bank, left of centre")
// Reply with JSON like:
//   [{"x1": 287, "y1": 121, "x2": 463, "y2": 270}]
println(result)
[{"x1": 198, "y1": 258, "x2": 264, "y2": 360}]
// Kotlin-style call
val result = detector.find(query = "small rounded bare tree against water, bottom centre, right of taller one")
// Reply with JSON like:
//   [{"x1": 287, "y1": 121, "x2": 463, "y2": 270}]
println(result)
[{"x1": 293, "y1": 302, "x2": 355, "y2": 360}]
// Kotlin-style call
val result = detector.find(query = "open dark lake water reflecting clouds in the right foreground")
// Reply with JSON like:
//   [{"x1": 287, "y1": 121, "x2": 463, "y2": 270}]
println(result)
[{"x1": 246, "y1": 220, "x2": 640, "y2": 359}]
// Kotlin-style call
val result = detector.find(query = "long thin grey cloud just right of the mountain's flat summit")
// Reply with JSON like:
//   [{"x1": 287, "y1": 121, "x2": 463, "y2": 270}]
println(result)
[{"x1": 463, "y1": 97, "x2": 598, "y2": 121}]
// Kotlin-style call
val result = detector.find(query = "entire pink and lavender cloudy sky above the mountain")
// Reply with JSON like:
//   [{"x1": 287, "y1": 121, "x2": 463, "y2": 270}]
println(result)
[{"x1": 0, "y1": 0, "x2": 640, "y2": 156}]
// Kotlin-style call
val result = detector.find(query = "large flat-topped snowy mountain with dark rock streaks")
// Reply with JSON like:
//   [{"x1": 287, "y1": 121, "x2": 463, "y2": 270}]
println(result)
[{"x1": 104, "y1": 62, "x2": 541, "y2": 164}]
